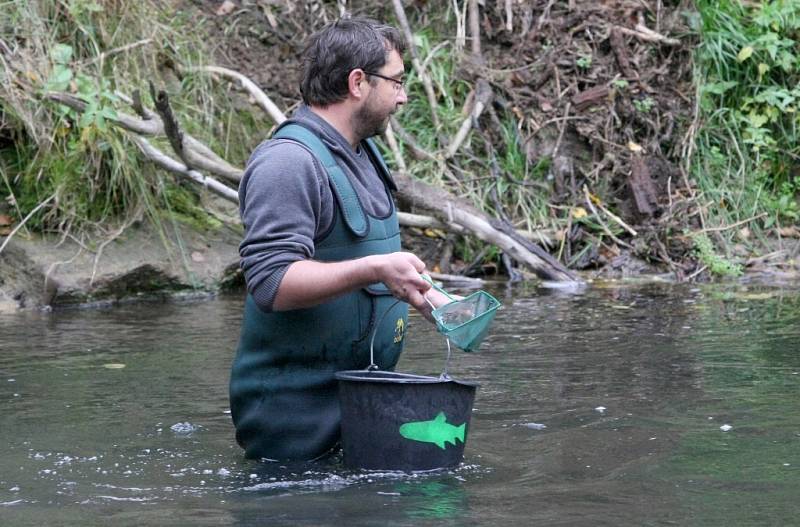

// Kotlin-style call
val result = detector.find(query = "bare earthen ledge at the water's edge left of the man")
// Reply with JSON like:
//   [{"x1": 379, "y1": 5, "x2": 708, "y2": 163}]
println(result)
[{"x1": 0, "y1": 220, "x2": 244, "y2": 311}]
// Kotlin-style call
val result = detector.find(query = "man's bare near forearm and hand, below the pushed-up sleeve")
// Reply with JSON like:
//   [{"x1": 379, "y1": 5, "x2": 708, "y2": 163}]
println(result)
[{"x1": 272, "y1": 252, "x2": 437, "y2": 313}]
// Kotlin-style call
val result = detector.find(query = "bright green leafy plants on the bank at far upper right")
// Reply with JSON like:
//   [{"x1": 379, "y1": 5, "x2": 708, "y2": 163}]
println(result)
[{"x1": 692, "y1": 0, "x2": 800, "y2": 233}]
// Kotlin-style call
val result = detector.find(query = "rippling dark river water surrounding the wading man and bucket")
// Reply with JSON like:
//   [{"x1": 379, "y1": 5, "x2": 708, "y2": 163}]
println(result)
[{"x1": 0, "y1": 283, "x2": 800, "y2": 526}]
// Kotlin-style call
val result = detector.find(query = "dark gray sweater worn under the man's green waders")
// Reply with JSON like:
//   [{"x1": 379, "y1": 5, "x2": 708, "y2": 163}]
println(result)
[{"x1": 239, "y1": 106, "x2": 391, "y2": 311}]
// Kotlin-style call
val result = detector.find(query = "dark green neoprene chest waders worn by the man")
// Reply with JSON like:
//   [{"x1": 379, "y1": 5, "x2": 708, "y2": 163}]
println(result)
[{"x1": 230, "y1": 124, "x2": 408, "y2": 460}]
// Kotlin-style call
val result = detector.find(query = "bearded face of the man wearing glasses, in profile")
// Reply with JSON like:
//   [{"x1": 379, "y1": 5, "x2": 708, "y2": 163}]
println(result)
[{"x1": 353, "y1": 50, "x2": 408, "y2": 139}]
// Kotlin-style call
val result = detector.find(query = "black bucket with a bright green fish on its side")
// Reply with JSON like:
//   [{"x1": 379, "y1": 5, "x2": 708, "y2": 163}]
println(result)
[{"x1": 336, "y1": 370, "x2": 478, "y2": 471}]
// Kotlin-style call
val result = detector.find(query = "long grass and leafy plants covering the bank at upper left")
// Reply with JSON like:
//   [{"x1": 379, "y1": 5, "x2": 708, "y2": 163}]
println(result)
[{"x1": 0, "y1": 0, "x2": 259, "y2": 242}]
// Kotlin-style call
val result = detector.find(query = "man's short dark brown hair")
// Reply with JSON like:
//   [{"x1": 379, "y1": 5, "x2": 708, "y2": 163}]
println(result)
[{"x1": 300, "y1": 17, "x2": 406, "y2": 106}]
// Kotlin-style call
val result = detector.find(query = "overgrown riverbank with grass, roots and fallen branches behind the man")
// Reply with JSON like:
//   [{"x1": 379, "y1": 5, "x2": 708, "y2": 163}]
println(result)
[{"x1": 0, "y1": 0, "x2": 800, "y2": 309}]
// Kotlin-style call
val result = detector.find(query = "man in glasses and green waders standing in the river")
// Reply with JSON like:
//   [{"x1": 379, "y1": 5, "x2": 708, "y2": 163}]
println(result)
[{"x1": 230, "y1": 18, "x2": 446, "y2": 460}]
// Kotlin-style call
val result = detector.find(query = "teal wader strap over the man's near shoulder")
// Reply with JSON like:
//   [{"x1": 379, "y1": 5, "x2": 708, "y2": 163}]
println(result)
[{"x1": 272, "y1": 124, "x2": 368, "y2": 238}]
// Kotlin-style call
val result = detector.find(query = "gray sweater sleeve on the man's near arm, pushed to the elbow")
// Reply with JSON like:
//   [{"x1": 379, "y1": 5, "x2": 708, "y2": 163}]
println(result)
[{"x1": 239, "y1": 140, "x2": 333, "y2": 312}]
